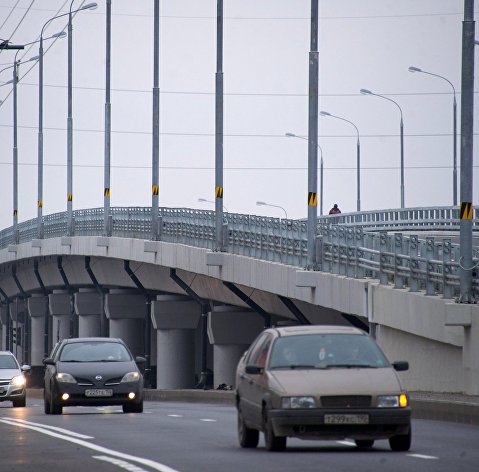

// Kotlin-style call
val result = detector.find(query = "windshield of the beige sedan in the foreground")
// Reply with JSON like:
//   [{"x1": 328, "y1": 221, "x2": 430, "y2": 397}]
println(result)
[{"x1": 269, "y1": 334, "x2": 390, "y2": 369}]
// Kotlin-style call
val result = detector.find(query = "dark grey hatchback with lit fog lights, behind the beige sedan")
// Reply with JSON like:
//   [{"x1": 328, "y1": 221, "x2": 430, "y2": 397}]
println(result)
[{"x1": 43, "y1": 338, "x2": 145, "y2": 415}]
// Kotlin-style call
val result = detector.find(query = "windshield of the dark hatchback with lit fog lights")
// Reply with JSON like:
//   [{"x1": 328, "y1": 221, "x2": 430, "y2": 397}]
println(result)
[{"x1": 59, "y1": 341, "x2": 131, "y2": 362}]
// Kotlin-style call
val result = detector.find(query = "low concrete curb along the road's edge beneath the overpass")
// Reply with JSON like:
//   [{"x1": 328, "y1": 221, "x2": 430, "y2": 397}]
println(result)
[{"x1": 27, "y1": 388, "x2": 479, "y2": 426}]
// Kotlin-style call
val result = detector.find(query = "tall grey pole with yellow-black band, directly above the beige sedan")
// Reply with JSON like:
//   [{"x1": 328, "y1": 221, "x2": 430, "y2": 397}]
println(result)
[{"x1": 307, "y1": 0, "x2": 319, "y2": 269}]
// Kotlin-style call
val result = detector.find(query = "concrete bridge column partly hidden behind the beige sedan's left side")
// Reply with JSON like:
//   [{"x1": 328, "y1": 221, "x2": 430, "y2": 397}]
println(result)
[{"x1": 208, "y1": 306, "x2": 264, "y2": 388}]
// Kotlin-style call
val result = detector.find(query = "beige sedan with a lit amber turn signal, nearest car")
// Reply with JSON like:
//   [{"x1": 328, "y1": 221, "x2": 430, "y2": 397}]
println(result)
[{"x1": 236, "y1": 326, "x2": 411, "y2": 451}]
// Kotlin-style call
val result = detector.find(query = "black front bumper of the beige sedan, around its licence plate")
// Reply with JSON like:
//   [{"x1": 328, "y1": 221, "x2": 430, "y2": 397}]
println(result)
[{"x1": 268, "y1": 408, "x2": 411, "y2": 439}]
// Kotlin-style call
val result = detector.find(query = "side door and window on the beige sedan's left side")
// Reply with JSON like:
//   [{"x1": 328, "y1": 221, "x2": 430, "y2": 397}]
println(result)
[{"x1": 243, "y1": 333, "x2": 273, "y2": 427}]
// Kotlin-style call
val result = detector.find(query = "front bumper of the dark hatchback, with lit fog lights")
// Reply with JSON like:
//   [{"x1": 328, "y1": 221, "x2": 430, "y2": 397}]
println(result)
[{"x1": 55, "y1": 382, "x2": 143, "y2": 406}]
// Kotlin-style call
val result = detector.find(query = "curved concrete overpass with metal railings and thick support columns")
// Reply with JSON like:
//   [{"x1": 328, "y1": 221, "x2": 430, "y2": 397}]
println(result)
[{"x1": 0, "y1": 207, "x2": 479, "y2": 394}]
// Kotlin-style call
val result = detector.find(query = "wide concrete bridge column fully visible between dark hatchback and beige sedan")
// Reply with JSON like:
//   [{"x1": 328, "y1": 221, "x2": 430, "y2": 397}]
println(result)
[{"x1": 152, "y1": 295, "x2": 201, "y2": 389}]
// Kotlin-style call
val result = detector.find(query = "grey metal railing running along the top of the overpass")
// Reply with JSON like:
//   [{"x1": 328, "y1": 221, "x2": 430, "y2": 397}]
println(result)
[{"x1": 0, "y1": 207, "x2": 479, "y2": 298}]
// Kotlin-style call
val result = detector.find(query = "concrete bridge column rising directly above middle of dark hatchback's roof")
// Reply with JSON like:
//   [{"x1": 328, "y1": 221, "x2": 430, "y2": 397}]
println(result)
[{"x1": 75, "y1": 288, "x2": 102, "y2": 338}]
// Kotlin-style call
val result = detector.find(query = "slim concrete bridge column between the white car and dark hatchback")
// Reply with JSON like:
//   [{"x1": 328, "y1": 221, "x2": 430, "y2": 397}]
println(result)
[{"x1": 27, "y1": 295, "x2": 48, "y2": 387}]
